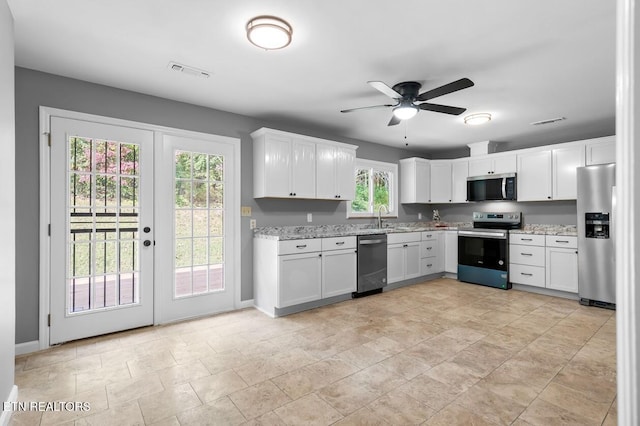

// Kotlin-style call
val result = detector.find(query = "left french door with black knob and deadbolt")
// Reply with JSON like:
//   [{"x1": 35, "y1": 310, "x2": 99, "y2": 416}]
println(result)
[{"x1": 49, "y1": 117, "x2": 154, "y2": 344}]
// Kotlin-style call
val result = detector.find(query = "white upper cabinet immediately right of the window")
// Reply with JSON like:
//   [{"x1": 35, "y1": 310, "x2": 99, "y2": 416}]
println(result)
[{"x1": 399, "y1": 157, "x2": 431, "y2": 204}]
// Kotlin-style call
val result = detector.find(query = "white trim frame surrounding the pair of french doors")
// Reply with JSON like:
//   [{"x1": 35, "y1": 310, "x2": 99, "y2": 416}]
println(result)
[{"x1": 38, "y1": 106, "x2": 244, "y2": 350}]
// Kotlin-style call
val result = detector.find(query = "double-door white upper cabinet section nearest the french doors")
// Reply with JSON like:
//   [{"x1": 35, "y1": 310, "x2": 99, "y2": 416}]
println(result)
[{"x1": 252, "y1": 129, "x2": 316, "y2": 198}]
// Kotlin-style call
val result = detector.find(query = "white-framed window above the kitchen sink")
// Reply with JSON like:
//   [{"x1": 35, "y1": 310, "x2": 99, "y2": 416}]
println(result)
[{"x1": 347, "y1": 158, "x2": 398, "y2": 217}]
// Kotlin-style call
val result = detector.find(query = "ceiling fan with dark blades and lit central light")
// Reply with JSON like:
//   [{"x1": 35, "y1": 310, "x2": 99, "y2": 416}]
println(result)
[{"x1": 340, "y1": 78, "x2": 473, "y2": 126}]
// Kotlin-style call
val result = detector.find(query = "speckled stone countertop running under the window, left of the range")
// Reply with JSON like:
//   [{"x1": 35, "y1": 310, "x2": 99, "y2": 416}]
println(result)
[{"x1": 253, "y1": 222, "x2": 471, "y2": 240}]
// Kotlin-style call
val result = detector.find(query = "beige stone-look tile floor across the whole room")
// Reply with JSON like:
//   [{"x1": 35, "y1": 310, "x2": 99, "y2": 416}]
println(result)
[{"x1": 10, "y1": 279, "x2": 616, "y2": 426}]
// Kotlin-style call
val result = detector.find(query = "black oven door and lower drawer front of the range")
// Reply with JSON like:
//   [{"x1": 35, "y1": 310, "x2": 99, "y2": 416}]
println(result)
[{"x1": 458, "y1": 231, "x2": 511, "y2": 290}]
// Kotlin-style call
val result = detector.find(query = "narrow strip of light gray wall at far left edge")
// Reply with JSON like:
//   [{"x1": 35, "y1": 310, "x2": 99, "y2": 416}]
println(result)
[{"x1": 0, "y1": 0, "x2": 16, "y2": 410}]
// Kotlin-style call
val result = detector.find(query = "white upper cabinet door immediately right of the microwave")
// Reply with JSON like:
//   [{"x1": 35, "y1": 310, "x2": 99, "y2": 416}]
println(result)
[{"x1": 517, "y1": 150, "x2": 552, "y2": 201}]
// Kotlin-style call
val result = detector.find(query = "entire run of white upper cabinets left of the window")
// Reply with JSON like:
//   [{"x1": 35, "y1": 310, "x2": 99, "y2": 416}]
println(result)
[{"x1": 251, "y1": 128, "x2": 357, "y2": 200}]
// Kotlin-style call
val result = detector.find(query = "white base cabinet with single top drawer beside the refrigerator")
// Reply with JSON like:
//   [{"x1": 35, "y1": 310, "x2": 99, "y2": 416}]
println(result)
[{"x1": 546, "y1": 235, "x2": 578, "y2": 293}]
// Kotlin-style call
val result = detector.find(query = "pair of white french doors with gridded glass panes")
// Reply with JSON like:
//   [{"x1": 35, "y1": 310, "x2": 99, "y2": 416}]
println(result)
[{"x1": 49, "y1": 116, "x2": 239, "y2": 344}]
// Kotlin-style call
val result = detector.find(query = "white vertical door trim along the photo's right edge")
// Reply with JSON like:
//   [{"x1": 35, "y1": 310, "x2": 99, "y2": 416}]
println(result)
[{"x1": 614, "y1": 0, "x2": 640, "y2": 425}]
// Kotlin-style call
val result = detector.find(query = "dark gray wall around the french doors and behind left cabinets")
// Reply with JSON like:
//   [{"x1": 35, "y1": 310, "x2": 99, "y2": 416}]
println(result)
[{"x1": 13, "y1": 68, "x2": 426, "y2": 343}]
